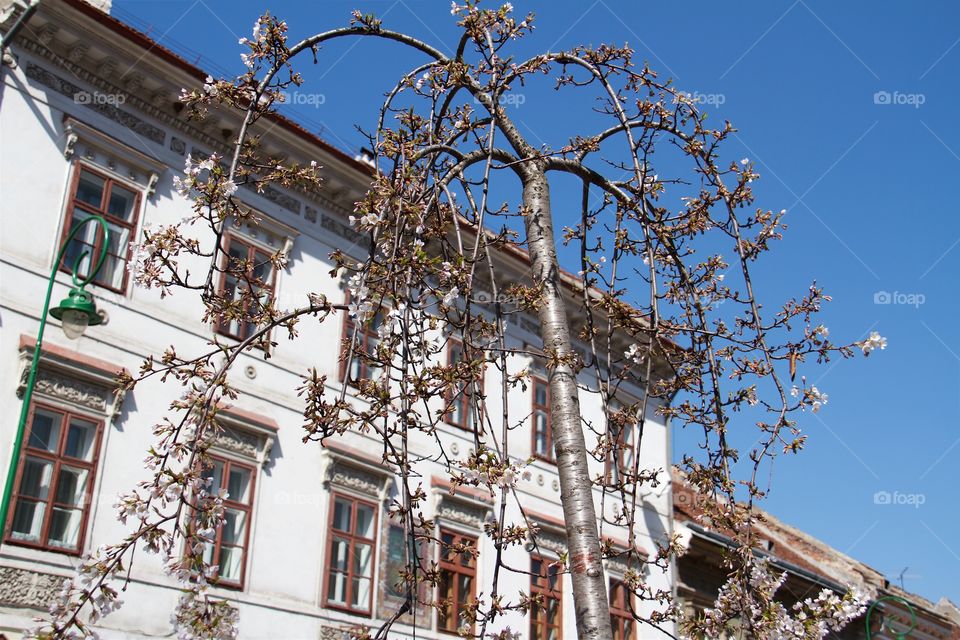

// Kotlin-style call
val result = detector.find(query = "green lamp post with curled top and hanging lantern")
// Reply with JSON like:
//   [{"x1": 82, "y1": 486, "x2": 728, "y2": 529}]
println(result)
[{"x1": 0, "y1": 216, "x2": 110, "y2": 544}]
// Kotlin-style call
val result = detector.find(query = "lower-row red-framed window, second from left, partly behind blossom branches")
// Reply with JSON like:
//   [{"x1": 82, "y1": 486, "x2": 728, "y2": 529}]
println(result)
[{"x1": 203, "y1": 457, "x2": 255, "y2": 588}]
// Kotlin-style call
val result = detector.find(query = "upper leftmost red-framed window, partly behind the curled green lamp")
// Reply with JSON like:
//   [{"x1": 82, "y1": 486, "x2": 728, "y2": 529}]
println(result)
[{"x1": 60, "y1": 163, "x2": 140, "y2": 293}]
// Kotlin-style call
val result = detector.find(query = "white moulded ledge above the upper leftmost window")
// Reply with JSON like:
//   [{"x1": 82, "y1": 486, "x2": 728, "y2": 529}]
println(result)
[{"x1": 63, "y1": 116, "x2": 166, "y2": 198}]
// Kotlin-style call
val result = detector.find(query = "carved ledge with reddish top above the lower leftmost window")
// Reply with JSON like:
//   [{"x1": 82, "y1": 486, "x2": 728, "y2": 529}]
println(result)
[{"x1": 16, "y1": 335, "x2": 126, "y2": 424}]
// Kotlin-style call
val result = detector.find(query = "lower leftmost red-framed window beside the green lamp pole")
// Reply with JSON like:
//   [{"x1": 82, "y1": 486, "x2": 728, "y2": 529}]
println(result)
[{"x1": 7, "y1": 405, "x2": 101, "y2": 553}]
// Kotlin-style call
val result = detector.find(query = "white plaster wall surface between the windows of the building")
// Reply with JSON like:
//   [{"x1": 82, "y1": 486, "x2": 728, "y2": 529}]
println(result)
[{"x1": 0, "y1": 38, "x2": 670, "y2": 639}]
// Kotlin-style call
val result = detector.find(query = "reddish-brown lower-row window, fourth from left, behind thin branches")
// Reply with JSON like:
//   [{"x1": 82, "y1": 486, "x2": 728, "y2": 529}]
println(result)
[{"x1": 437, "y1": 529, "x2": 477, "y2": 633}]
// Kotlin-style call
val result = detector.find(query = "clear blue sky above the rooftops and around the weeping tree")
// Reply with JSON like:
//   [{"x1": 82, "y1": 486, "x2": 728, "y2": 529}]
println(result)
[{"x1": 114, "y1": 0, "x2": 960, "y2": 603}]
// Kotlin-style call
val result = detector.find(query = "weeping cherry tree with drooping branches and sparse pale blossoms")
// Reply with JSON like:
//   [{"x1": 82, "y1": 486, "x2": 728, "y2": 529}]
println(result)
[{"x1": 31, "y1": 2, "x2": 885, "y2": 639}]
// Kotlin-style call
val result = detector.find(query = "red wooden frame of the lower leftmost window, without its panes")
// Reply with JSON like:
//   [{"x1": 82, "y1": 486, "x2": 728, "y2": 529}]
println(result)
[{"x1": 4, "y1": 402, "x2": 103, "y2": 556}]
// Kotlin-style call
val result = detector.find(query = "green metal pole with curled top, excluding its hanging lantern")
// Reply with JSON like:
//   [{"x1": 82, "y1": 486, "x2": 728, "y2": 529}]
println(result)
[{"x1": 0, "y1": 216, "x2": 110, "y2": 545}]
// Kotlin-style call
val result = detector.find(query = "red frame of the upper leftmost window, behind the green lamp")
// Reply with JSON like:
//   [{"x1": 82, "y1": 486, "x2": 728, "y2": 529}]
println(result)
[{"x1": 58, "y1": 161, "x2": 143, "y2": 294}]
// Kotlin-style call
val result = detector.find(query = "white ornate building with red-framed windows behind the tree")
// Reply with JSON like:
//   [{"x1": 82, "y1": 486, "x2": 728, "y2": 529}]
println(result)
[{"x1": 0, "y1": 0, "x2": 672, "y2": 639}]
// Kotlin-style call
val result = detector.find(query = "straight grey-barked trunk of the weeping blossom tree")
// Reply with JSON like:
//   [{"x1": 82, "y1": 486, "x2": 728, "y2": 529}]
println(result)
[{"x1": 523, "y1": 163, "x2": 613, "y2": 640}]
